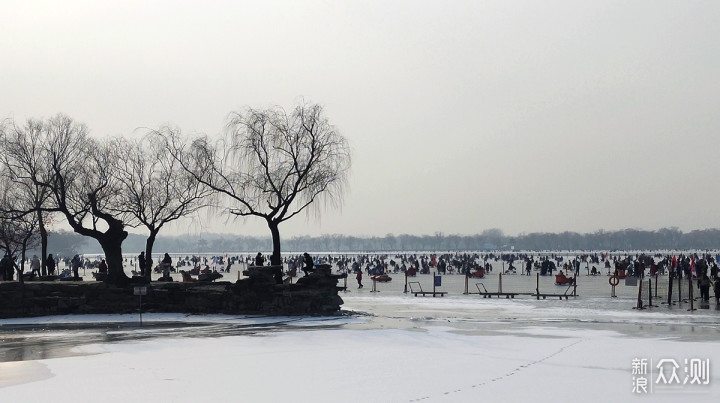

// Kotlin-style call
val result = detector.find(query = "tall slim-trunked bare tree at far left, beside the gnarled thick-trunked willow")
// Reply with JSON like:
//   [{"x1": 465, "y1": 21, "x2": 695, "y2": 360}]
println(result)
[{"x1": 0, "y1": 119, "x2": 54, "y2": 274}]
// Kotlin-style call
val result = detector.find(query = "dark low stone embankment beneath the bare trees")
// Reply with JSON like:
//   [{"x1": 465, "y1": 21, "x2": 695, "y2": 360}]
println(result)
[{"x1": 0, "y1": 267, "x2": 344, "y2": 318}]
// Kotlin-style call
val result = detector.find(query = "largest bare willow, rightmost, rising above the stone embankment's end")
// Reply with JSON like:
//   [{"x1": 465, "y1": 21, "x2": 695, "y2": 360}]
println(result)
[{"x1": 166, "y1": 103, "x2": 351, "y2": 265}]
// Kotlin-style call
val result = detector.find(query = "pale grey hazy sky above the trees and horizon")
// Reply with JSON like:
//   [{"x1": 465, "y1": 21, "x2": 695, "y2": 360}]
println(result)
[{"x1": 0, "y1": 0, "x2": 720, "y2": 237}]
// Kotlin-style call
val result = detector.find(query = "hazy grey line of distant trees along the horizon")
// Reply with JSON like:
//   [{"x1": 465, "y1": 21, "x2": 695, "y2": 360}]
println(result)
[{"x1": 49, "y1": 228, "x2": 720, "y2": 255}]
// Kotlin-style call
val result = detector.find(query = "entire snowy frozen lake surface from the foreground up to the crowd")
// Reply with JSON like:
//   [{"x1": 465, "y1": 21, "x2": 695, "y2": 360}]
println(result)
[{"x1": 0, "y1": 270, "x2": 720, "y2": 402}]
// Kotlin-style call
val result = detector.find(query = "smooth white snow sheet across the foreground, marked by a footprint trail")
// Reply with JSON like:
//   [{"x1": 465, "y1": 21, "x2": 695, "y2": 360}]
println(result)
[{"x1": 0, "y1": 327, "x2": 720, "y2": 402}]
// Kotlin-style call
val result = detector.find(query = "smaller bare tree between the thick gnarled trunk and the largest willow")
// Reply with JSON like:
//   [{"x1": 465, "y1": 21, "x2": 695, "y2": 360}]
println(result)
[{"x1": 113, "y1": 133, "x2": 213, "y2": 278}]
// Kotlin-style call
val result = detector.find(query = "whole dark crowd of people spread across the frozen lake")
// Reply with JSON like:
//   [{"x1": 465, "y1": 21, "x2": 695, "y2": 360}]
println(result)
[{"x1": 0, "y1": 252, "x2": 720, "y2": 300}]
